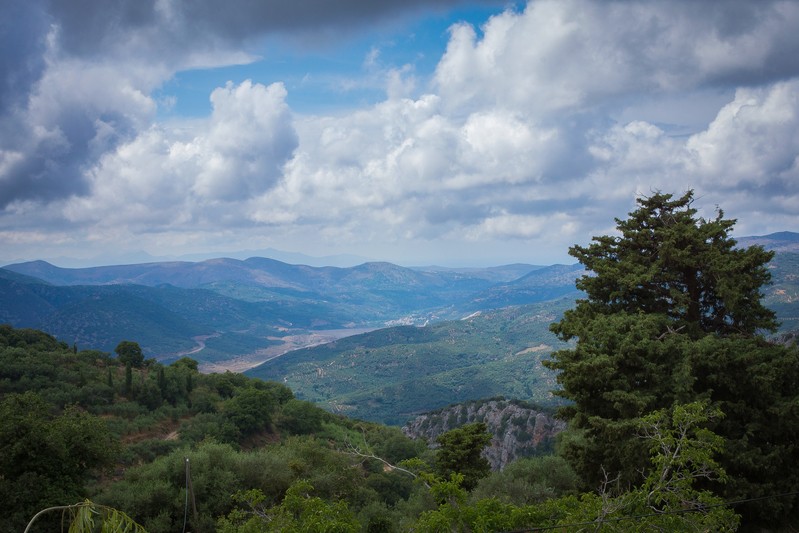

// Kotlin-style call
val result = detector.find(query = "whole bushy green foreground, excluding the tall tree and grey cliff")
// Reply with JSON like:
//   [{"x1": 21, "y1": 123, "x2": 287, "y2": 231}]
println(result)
[{"x1": 0, "y1": 326, "x2": 756, "y2": 533}]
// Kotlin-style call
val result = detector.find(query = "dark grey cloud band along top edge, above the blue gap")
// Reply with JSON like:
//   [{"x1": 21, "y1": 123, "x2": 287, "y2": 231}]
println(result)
[{"x1": 46, "y1": 0, "x2": 507, "y2": 55}]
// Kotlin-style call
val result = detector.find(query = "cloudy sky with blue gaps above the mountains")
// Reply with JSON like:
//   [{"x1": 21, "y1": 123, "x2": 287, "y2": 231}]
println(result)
[{"x1": 0, "y1": 0, "x2": 799, "y2": 266}]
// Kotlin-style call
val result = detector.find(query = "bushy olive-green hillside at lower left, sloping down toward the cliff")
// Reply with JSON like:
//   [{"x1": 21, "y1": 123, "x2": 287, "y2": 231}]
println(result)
[{"x1": 0, "y1": 326, "x2": 426, "y2": 532}]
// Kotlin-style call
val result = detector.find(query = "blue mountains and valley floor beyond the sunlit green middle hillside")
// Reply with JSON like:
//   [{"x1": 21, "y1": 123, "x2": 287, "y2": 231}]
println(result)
[{"x1": 0, "y1": 252, "x2": 582, "y2": 363}]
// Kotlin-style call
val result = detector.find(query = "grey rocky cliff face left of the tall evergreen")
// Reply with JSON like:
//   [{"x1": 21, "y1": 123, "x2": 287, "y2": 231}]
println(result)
[{"x1": 402, "y1": 399, "x2": 566, "y2": 470}]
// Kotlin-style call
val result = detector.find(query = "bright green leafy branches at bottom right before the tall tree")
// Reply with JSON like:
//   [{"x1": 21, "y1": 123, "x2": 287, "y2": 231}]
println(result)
[{"x1": 416, "y1": 403, "x2": 739, "y2": 532}]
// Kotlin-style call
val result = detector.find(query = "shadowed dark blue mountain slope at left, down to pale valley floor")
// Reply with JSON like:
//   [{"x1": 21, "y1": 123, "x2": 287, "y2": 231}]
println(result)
[{"x1": 0, "y1": 269, "x2": 351, "y2": 361}]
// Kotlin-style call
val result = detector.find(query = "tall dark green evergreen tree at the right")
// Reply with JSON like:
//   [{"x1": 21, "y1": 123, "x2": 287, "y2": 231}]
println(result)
[{"x1": 547, "y1": 191, "x2": 799, "y2": 521}]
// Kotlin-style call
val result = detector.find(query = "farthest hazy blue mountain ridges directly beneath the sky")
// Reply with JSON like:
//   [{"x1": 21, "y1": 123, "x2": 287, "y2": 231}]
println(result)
[{"x1": 5, "y1": 258, "x2": 548, "y2": 325}]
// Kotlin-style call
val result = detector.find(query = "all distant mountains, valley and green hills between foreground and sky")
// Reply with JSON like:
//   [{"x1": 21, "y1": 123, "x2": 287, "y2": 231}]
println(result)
[{"x1": 0, "y1": 232, "x2": 799, "y2": 424}]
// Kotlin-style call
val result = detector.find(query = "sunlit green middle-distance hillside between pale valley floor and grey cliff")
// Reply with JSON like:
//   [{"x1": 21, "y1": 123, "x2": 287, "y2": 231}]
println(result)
[{"x1": 246, "y1": 299, "x2": 573, "y2": 425}]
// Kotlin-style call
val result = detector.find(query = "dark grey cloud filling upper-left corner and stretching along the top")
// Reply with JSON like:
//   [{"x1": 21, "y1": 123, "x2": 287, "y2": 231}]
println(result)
[{"x1": 0, "y1": 0, "x2": 506, "y2": 209}]
